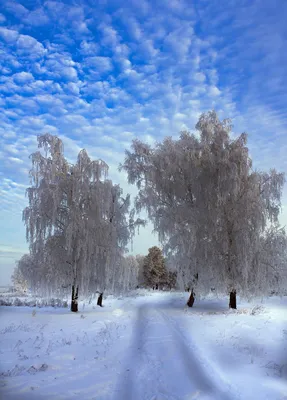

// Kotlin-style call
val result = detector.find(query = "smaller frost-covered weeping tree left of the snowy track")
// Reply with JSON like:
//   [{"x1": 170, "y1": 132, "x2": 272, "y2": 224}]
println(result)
[{"x1": 23, "y1": 134, "x2": 143, "y2": 311}]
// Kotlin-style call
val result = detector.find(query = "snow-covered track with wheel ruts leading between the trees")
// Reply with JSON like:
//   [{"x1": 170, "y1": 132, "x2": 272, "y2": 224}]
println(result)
[{"x1": 113, "y1": 304, "x2": 239, "y2": 400}]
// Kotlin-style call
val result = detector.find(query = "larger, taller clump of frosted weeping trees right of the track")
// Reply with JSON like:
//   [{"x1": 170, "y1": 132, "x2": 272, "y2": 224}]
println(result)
[{"x1": 120, "y1": 111, "x2": 287, "y2": 308}]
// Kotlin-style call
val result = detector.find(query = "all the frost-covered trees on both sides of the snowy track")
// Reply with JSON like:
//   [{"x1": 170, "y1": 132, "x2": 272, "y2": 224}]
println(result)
[{"x1": 14, "y1": 111, "x2": 287, "y2": 311}]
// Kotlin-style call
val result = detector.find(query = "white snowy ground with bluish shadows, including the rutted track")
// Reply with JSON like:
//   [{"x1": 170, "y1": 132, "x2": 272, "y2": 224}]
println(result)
[{"x1": 0, "y1": 292, "x2": 287, "y2": 400}]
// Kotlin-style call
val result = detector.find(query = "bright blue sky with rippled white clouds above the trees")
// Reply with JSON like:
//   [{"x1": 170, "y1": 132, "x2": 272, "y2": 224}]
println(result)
[{"x1": 0, "y1": 0, "x2": 287, "y2": 285}]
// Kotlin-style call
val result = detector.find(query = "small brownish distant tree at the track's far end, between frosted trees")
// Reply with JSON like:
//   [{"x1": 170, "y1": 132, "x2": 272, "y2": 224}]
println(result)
[{"x1": 143, "y1": 246, "x2": 167, "y2": 289}]
